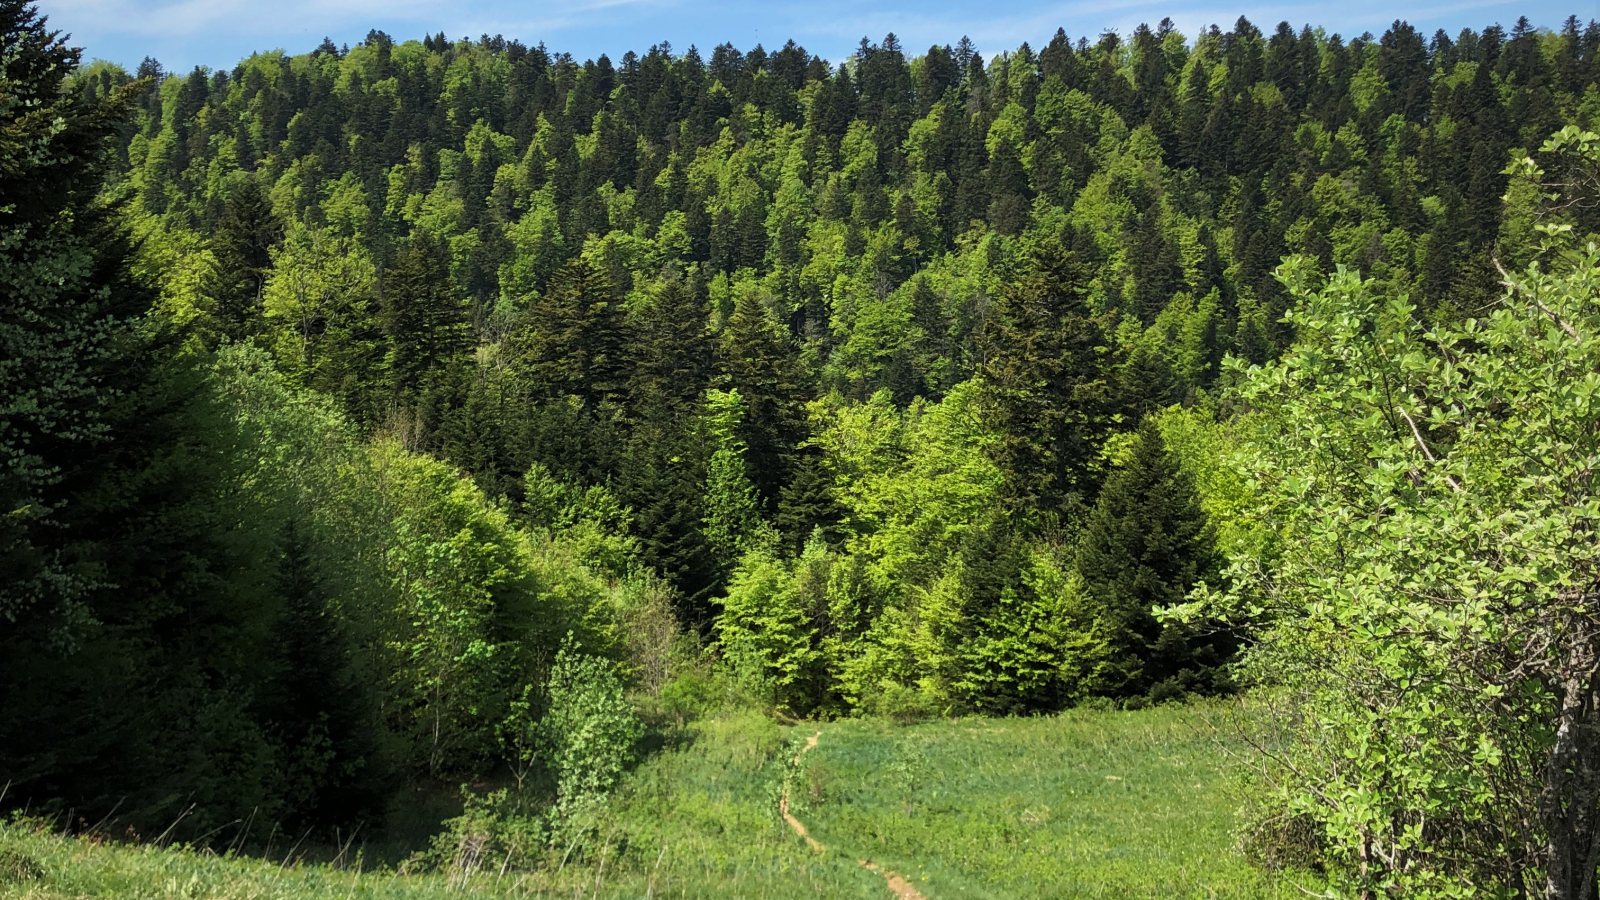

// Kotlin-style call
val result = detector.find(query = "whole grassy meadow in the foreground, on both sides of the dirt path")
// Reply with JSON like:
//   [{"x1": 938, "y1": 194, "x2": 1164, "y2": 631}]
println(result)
[{"x1": 0, "y1": 708, "x2": 1312, "y2": 900}]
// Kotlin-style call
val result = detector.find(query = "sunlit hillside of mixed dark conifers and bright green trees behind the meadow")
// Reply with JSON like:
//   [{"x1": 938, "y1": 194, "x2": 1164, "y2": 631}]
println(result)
[{"x1": 96, "y1": 12, "x2": 1600, "y2": 713}]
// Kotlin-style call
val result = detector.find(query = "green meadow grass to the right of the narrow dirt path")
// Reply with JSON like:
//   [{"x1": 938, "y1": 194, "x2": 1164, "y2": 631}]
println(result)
[{"x1": 797, "y1": 706, "x2": 1315, "y2": 898}]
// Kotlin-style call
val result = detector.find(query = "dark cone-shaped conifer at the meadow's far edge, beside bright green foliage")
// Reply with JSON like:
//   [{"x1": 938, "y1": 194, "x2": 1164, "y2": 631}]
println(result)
[{"x1": 1077, "y1": 420, "x2": 1232, "y2": 698}]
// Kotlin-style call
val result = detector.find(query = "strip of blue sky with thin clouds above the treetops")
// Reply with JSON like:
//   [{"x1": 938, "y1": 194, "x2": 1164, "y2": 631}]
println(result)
[{"x1": 38, "y1": 0, "x2": 1600, "y2": 70}]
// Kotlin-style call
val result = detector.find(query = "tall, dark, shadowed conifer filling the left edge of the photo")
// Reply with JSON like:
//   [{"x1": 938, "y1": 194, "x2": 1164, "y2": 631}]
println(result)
[{"x1": 0, "y1": 8, "x2": 288, "y2": 830}]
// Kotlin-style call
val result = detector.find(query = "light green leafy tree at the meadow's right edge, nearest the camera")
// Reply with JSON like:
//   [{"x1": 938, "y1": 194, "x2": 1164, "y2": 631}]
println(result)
[{"x1": 1203, "y1": 245, "x2": 1600, "y2": 898}]
